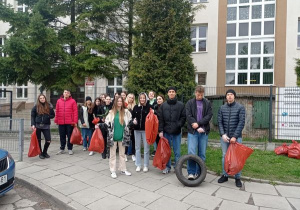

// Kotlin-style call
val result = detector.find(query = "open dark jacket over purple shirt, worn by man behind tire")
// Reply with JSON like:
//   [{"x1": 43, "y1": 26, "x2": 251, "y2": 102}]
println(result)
[{"x1": 185, "y1": 98, "x2": 213, "y2": 134}]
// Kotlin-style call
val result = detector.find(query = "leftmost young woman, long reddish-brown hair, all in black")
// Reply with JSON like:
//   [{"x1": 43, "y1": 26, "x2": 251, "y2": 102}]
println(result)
[{"x1": 31, "y1": 94, "x2": 55, "y2": 159}]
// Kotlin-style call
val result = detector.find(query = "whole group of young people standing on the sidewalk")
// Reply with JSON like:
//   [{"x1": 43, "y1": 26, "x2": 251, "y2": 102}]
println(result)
[{"x1": 31, "y1": 86, "x2": 245, "y2": 187}]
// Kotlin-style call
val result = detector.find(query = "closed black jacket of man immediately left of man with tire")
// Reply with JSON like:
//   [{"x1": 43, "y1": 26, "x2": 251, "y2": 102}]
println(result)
[{"x1": 158, "y1": 98, "x2": 186, "y2": 135}]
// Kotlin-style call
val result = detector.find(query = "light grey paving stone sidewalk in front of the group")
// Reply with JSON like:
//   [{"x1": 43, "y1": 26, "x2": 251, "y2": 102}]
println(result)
[{"x1": 16, "y1": 140, "x2": 300, "y2": 210}]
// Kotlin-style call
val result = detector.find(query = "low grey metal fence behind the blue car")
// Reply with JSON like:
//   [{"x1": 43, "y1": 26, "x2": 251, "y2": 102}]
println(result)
[{"x1": 0, "y1": 118, "x2": 24, "y2": 161}]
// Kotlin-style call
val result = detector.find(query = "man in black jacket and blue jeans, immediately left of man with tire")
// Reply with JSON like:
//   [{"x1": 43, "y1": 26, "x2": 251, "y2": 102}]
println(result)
[{"x1": 158, "y1": 87, "x2": 186, "y2": 174}]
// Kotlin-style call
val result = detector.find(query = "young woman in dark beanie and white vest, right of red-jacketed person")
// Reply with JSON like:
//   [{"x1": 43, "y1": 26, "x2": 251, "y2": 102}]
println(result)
[{"x1": 79, "y1": 96, "x2": 94, "y2": 155}]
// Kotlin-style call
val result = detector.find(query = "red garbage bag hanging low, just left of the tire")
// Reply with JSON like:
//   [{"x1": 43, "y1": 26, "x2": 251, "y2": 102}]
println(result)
[{"x1": 153, "y1": 137, "x2": 171, "y2": 170}]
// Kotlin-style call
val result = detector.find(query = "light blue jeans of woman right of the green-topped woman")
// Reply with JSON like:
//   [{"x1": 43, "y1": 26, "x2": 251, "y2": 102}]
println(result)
[{"x1": 134, "y1": 131, "x2": 150, "y2": 167}]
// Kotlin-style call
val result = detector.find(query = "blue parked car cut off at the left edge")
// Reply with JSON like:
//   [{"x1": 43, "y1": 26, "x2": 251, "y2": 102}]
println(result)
[{"x1": 0, "y1": 149, "x2": 15, "y2": 196}]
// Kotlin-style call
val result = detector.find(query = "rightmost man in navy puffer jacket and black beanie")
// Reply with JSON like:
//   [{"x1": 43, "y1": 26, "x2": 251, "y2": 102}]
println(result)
[{"x1": 218, "y1": 89, "x2": 246, "y2": 187}]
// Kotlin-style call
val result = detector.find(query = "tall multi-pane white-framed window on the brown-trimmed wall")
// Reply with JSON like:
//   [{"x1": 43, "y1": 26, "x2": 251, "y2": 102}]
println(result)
[{"x1": 225, "y1": 0, "x2": 276, "y2": 85}]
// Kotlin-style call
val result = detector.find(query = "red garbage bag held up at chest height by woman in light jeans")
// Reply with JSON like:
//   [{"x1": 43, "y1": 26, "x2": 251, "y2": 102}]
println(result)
[{"x1": 145, "y1": 109, "x2": 158, "y2": 145}]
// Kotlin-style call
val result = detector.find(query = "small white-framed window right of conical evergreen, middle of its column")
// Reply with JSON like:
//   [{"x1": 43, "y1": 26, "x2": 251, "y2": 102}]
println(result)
[{"x1": 191, "y1": 25, "x2": 207, "y2": 52}]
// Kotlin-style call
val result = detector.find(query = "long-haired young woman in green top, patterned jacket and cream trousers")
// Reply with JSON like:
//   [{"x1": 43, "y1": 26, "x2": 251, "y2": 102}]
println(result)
[{"x1": 105, "y1": 96, "x2": 131, "y2": 178}]
